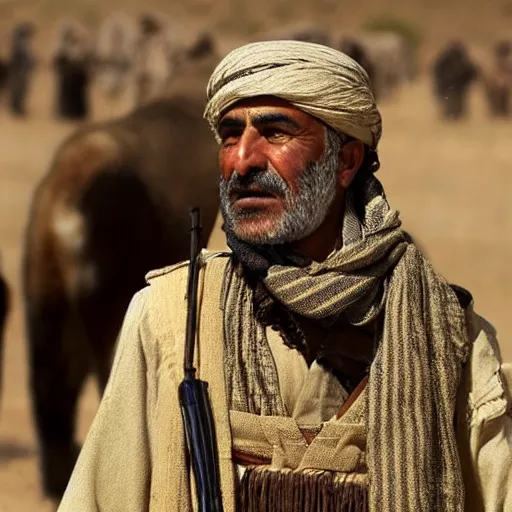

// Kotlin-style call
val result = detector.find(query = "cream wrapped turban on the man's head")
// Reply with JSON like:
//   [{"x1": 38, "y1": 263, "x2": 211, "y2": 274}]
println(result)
[{"x1": 204, "y1": 41, "x2": 382, "y2": 149}]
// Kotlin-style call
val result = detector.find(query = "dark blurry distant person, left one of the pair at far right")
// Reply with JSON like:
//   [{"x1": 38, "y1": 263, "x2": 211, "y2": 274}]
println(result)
[{"x1": 433, "y1": 41, "x2": 478, "y2": 120}]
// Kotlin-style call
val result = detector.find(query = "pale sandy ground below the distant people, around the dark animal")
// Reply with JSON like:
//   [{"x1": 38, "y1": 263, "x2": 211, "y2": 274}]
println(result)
[{"x1": 0, "y1": 65, "x2": 512, "y2": 512}]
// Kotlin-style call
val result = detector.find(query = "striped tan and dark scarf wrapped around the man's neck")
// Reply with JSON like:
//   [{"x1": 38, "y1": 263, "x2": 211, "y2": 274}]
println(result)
[{"x1": 224, "y1": 175, "x2": 469, "y2": 512}]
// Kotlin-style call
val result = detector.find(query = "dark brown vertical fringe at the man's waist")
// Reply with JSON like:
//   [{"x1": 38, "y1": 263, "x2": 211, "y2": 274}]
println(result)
[{"x1": 240, "y1": 466, "x2": 368, "y2": 512}]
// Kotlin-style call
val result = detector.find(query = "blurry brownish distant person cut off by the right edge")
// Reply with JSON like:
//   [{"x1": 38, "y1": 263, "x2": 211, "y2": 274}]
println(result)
[{"x1": 485, "y1": 40, "x2": 512, "y2": 117}]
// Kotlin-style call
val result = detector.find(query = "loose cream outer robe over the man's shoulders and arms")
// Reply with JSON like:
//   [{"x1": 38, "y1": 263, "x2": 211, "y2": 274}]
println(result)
[{"x1": 59, "y1": 256, "x2": 512, "y2": 512}]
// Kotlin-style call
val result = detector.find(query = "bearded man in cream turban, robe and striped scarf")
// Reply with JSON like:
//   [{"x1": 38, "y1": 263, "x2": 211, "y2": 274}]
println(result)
[{"x1": 60, "y1": 41, "x2": 512, "y2": 512}]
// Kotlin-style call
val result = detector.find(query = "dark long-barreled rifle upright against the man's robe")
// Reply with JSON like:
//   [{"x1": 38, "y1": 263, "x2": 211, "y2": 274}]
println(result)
[{"x1": 178, "y1": 208, "x2": 223, "y2": 512}]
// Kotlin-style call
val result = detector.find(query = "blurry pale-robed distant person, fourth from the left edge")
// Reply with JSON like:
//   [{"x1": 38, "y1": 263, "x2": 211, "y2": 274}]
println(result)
[{"x1": 134, "y1": 14, "x2": 171, "y2": 105}]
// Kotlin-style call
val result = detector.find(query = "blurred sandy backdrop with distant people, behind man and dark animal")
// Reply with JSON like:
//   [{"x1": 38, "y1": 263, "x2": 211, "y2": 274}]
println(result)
[{"x1": 0, "y1": 0, "x2": 512, "y2": 512}]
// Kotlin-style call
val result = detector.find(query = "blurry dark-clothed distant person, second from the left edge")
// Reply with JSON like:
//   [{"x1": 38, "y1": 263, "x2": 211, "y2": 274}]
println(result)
[{"x1": 53, "y1": 24, "x2": 91, "y2": 120}]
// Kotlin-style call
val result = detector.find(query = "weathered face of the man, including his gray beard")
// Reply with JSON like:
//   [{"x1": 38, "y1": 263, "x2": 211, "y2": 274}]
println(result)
[{"x1": 218, "y1": 97, "x2": 340, "y2": 244}]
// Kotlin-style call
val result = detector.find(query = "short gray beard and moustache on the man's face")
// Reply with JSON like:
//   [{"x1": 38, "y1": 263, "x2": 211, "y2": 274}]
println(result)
[{"x1": 220, "y1": 130, "x2": 341, "y2": 245}]
